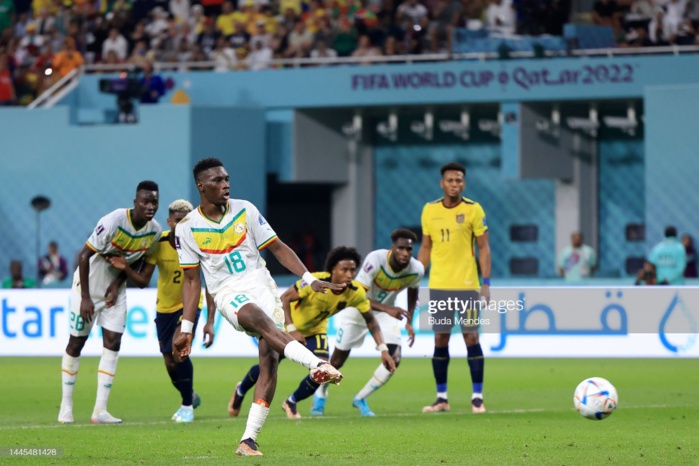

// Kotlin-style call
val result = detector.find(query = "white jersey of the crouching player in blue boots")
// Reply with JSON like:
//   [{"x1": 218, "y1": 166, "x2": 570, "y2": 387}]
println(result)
[{"x1": 356, "y1": 249, "x2": 425, "y2": 306}]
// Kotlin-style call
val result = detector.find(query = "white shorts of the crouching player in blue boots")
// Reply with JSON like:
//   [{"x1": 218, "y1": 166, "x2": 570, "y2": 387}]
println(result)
[{"x1": 335, "y1": 307, "x2": 402, "y2": 351}]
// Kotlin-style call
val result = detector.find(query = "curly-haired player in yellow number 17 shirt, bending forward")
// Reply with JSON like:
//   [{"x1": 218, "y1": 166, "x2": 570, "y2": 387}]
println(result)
[{"x1": 228, "y1": 246, "x2": 396, "y2": 419}]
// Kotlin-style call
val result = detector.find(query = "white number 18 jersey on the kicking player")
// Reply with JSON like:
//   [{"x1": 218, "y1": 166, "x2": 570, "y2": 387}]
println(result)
[{"x1": 175, "y1": 199, "x2": 277, "y2": 296}]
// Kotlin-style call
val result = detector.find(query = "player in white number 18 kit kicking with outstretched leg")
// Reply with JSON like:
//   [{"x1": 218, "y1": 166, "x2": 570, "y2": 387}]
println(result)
[{"x1": 174, "y1": 158, "x2": 346, "y2": 456}]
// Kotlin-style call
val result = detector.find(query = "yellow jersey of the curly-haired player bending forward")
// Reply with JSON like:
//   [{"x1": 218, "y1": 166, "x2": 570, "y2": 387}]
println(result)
[{"x1": 291, "y1": 272, "x2": 371, "y2": 337}]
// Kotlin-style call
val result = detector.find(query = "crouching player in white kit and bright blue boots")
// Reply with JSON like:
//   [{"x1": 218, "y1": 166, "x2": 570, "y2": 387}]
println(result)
[{"x1": 311, "y1": 229, "x2": 425, "y2": 416}]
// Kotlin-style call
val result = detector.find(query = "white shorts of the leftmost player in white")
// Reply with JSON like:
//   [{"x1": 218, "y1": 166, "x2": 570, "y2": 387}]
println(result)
[{"x1": 70, "y1": 282, "x2": 126, "y2": 337}]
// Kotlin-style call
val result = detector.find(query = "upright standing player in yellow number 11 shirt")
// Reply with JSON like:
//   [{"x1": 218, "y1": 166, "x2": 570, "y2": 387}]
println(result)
[{"x1": 418, "y1": 163, "x2": 491, "y2": 413}]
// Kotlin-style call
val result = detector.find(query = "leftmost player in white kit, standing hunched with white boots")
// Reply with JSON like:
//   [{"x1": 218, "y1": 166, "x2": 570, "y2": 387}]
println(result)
[{"x1": 58, "y1": 181, "x2": 162, "y2": 424}]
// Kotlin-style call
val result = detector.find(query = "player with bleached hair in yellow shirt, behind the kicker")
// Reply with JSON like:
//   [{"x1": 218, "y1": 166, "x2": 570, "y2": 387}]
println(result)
[{"x1": 106, "y1": 199, "x2": 216, "y2": 422}]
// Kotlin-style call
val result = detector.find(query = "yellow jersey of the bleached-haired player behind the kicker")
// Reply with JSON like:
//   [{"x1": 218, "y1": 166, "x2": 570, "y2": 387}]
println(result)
[{"x1": 146, "y1": 230, "x2": 204, "y2": 314}]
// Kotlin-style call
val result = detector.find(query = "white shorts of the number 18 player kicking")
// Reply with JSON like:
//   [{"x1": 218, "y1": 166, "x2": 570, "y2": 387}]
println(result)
[{"x1": 216, "y1": 277, "x2": 284, "y2": 337}]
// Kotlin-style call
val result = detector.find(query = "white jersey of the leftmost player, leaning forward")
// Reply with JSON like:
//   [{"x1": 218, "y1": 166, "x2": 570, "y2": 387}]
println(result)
[{"x1": 74, "y1": 209, "x2": 162, "y2": 296}]
